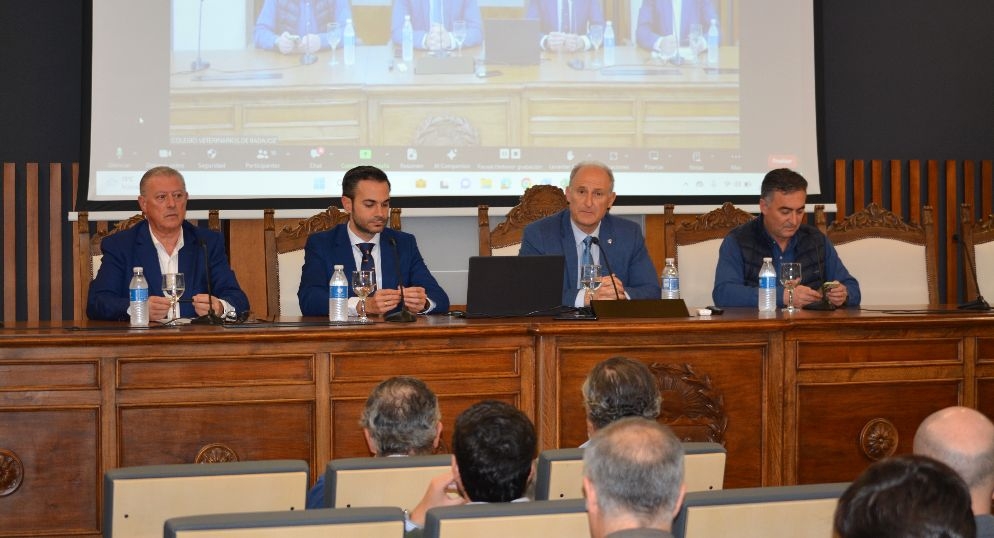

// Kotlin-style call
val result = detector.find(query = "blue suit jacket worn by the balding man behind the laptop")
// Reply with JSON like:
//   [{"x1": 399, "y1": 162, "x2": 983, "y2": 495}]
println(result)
[{"x1": 518, "y1": 209, "x2": 662, "y2": 306}]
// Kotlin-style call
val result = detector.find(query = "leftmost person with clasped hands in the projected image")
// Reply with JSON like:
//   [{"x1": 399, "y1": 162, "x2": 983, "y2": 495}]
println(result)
[{"x1": 254, "y1": 0, "x2": 352, "y2": 54}]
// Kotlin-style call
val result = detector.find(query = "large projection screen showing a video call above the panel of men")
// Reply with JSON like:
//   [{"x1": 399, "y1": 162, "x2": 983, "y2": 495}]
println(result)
[{"x1": 90, "y1": 0, "x2": 817, "y2": 204}]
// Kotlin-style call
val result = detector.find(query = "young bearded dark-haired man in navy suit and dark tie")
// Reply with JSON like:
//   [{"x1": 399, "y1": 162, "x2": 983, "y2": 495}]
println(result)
[{"x1": 297, "y1": 166, "x2": 449, "y2": 316}]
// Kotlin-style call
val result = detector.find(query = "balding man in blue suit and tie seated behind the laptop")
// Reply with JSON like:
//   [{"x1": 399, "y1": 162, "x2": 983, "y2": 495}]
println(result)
[{"x1": 518, "y1": 162, "x2": 661, "y2": 307}]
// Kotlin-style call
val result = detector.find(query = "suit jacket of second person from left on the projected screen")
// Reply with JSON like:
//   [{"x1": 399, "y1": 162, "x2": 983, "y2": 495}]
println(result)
[{"x1": 390, "y1": 0, "x2": 483, "y2": 49}]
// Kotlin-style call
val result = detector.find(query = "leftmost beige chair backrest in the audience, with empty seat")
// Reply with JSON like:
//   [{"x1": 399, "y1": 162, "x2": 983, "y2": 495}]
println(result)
[{"x1": 104, "y1": 460, "x2": 308, "y2": 538}]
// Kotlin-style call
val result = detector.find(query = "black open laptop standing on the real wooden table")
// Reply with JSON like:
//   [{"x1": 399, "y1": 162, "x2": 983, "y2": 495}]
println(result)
[{"x1": 466, "y1": 256, "x2": 566, "y2": 318}]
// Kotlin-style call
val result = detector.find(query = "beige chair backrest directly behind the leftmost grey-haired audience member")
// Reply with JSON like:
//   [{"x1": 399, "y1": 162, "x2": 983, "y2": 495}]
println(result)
[{"x1": 324, "y1": 454, "x2": 452, "y2": 508}]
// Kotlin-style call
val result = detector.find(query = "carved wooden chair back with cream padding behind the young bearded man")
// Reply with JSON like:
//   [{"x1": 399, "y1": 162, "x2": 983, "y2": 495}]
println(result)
[{"x1": 263, "y1": 205, "x2": 400, "y2": 317}]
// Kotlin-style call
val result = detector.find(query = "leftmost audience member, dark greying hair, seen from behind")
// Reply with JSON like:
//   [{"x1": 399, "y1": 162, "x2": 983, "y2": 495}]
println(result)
[{"x1": 307, "y1": 376, "x2": 442, "y2": 509}]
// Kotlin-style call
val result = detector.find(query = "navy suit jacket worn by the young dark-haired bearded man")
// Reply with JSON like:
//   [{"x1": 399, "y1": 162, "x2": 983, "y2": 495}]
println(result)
[{"x1": 297, "y1": 224, "x2": 449, "y2": 316}]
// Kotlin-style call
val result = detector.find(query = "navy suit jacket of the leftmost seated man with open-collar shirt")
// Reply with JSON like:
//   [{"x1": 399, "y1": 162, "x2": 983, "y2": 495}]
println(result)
[{"x1": 86, "y1": 221, "x2": 249, "y2": 321}]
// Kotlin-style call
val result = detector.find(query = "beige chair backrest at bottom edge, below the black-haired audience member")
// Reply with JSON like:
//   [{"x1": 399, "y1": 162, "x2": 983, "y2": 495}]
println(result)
[{"x1": 424, "y1": 499, "x2": 590, "y2": 538}]
